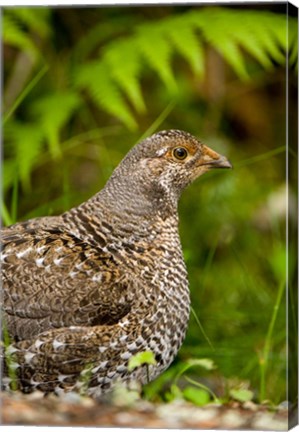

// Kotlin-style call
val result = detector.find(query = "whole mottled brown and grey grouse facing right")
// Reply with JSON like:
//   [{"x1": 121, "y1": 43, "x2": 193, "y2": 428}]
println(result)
[{"x1": 2, "y1": 130, "x2": 231, "y2": 396}]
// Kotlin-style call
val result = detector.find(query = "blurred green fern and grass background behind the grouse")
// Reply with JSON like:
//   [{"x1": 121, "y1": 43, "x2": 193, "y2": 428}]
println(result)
[{"x1": 2, "y1": 4, "x2": 297, "y2": 403}]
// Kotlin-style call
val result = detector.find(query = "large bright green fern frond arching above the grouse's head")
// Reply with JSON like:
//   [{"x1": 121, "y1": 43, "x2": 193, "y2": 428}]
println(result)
[{"x1": 75, "y1": 8, "x2": 295, "y2": 128}]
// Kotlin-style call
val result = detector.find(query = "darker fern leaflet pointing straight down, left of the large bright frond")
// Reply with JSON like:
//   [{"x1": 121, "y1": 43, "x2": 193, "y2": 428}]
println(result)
[{"x1": 32, "y1": 91, "x2": 80, "y2": 158}]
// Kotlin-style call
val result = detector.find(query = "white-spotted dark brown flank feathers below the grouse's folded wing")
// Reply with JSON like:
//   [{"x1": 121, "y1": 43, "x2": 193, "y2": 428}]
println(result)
[{"x1": 4, "y1": 323, "x2": 128, "y2": 393}]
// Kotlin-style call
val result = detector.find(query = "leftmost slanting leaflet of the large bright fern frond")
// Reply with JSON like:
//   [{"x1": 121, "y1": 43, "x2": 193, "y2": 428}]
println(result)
[{"x1": 74, "y1": 61, "x2": 137, "y2": 130}]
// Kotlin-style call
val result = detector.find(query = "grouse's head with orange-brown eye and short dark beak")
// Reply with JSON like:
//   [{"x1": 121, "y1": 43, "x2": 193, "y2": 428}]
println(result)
[{"x1": 104, "y1": 130, "x2": 232, "y2": 216}]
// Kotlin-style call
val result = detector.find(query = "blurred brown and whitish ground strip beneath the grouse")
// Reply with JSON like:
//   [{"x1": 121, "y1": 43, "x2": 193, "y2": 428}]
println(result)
[{"x1": 1, "y1": 392, "x2": 297, "y2": 431}]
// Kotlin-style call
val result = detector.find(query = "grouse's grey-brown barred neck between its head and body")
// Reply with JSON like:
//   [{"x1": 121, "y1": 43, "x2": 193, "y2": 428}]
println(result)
[{"x1": 63, "y1": 173, "x2": 178, "y2": 246}]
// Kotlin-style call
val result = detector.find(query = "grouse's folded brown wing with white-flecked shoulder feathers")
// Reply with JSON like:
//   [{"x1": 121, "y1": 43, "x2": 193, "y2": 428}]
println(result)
[{"x1": 2, "y1": 218, "x2": 134, "y2": 340}]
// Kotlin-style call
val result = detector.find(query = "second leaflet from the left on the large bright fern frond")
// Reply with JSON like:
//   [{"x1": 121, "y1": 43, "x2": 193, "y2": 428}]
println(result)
[{"x1": 103, "y1": 39, "x2": 145, "y2": 112}]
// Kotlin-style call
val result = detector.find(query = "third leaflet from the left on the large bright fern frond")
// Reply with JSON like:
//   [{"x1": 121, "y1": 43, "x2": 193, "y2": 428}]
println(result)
[{"x1": 135, "y1": 24, "x2": 177, "y2": 92}]
